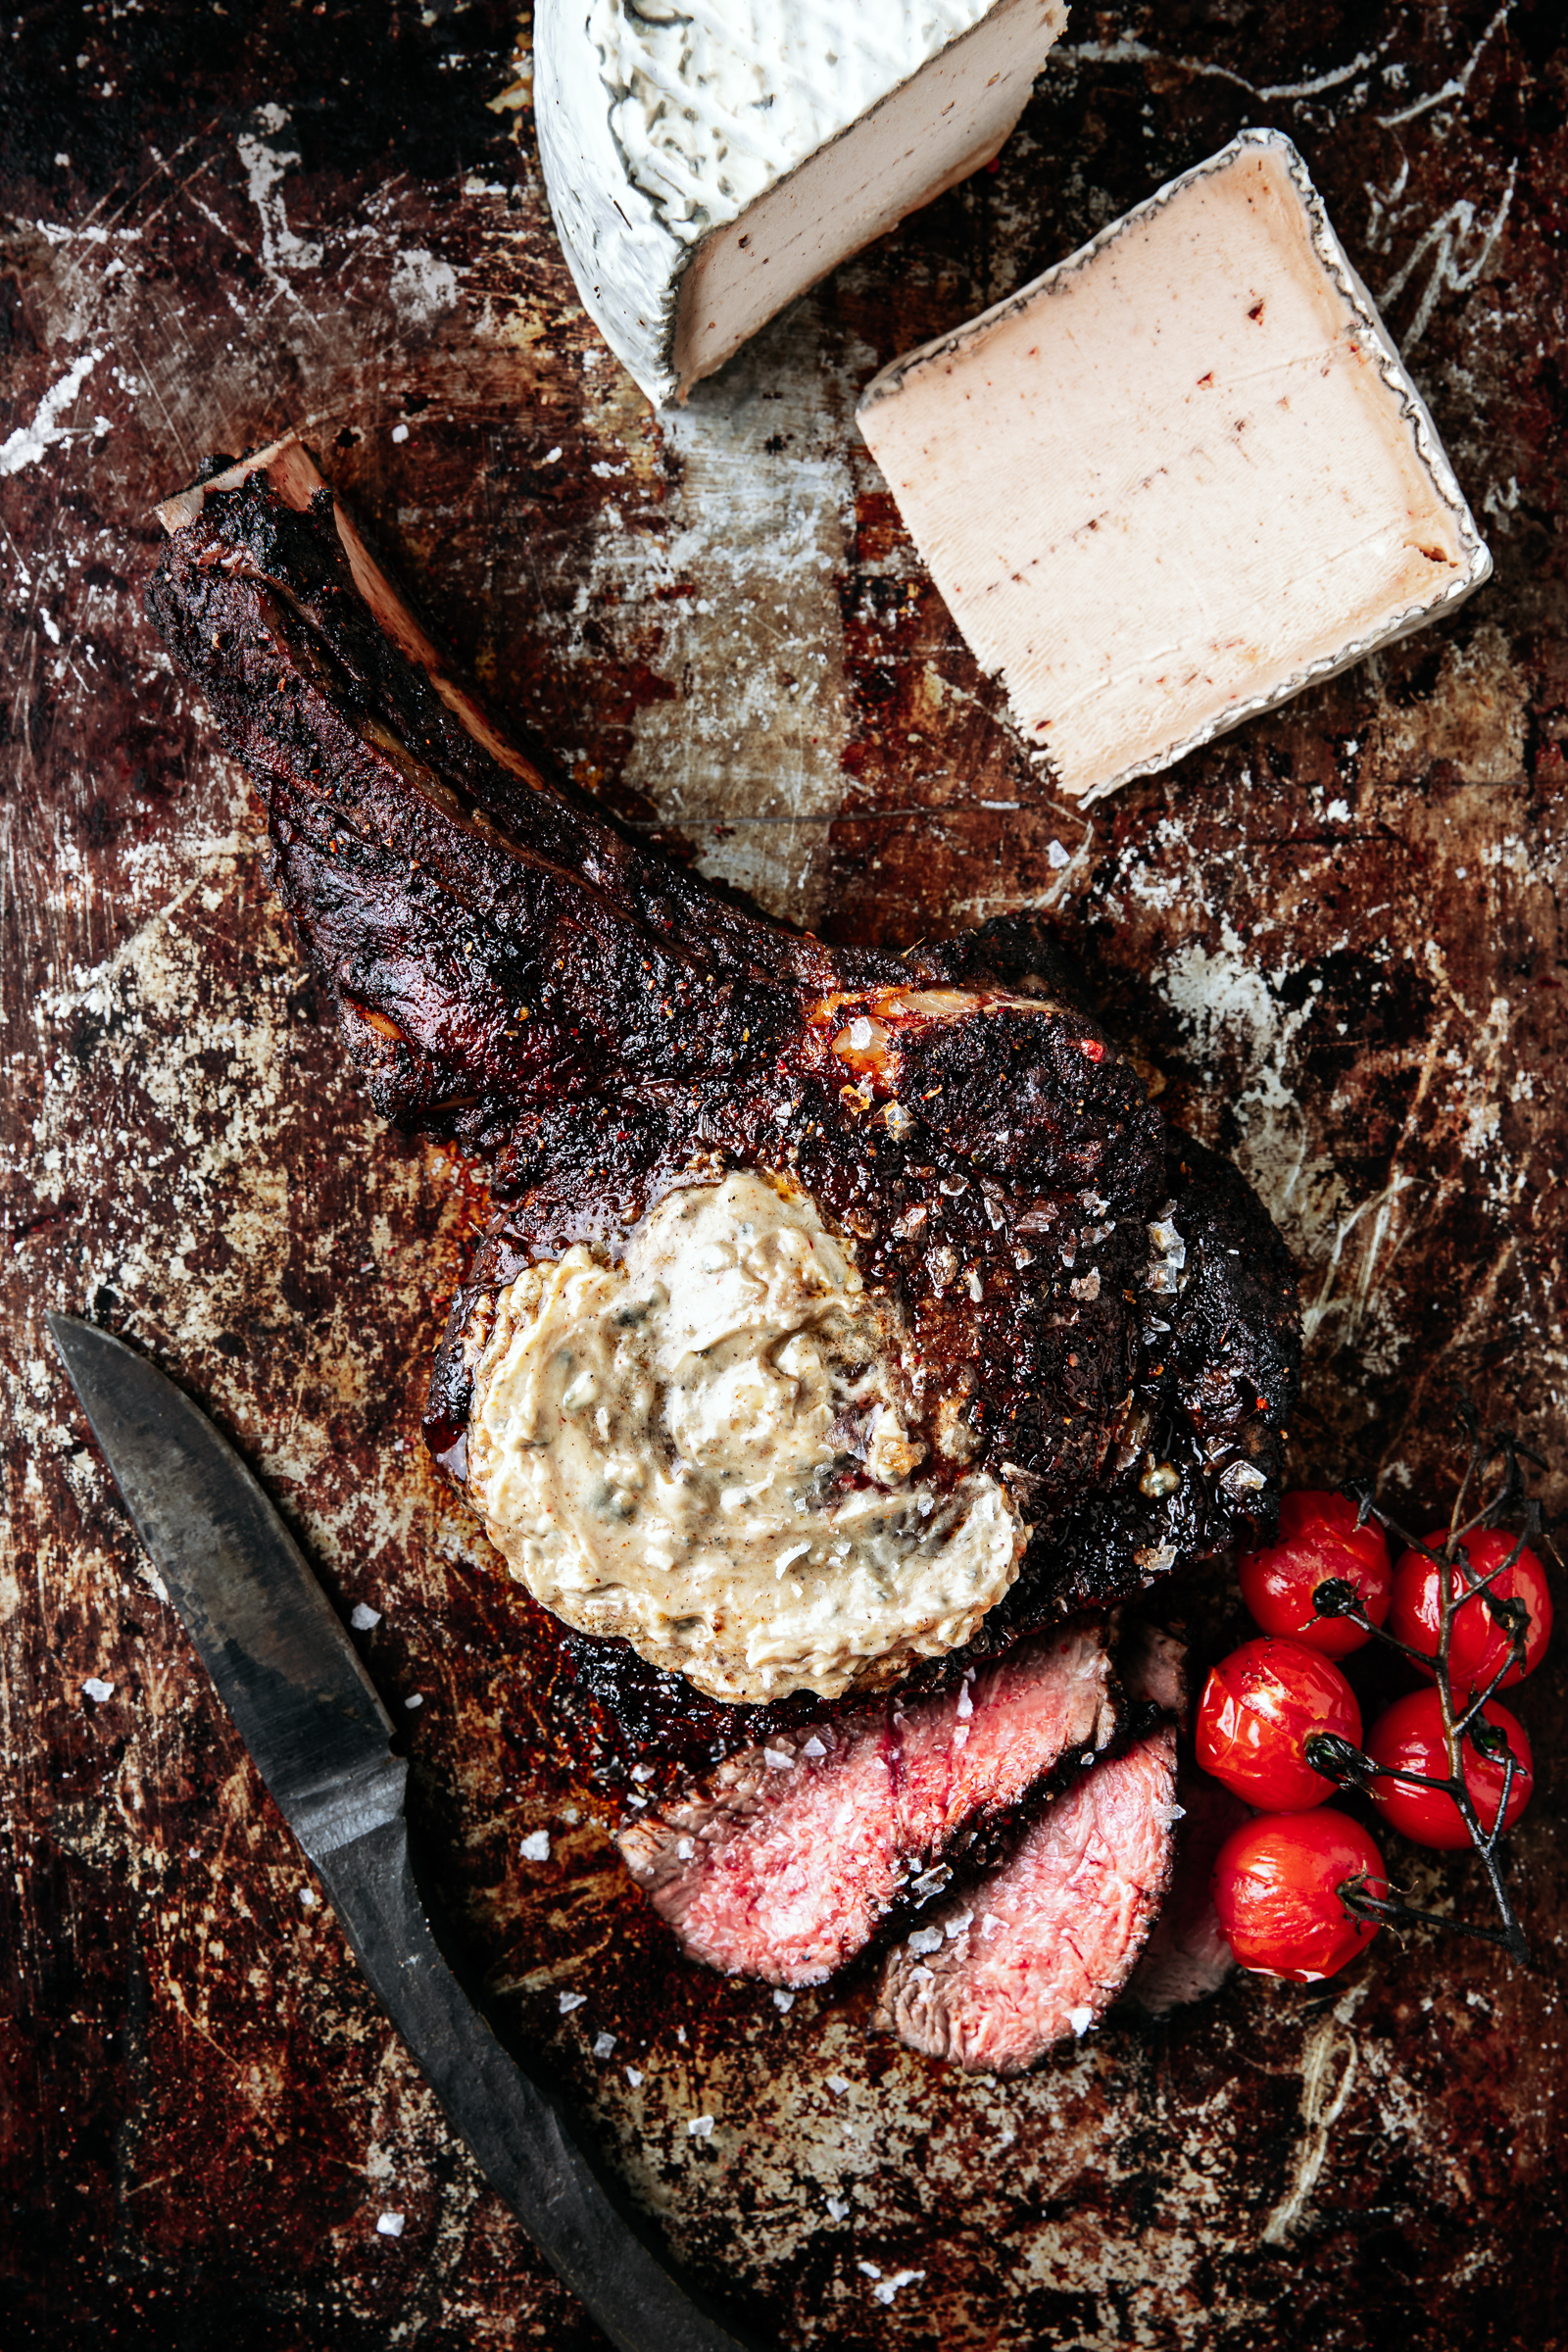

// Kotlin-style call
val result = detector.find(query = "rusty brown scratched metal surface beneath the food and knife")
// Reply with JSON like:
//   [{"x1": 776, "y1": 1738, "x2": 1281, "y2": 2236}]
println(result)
[{"x1": 0, "y1": 0, "x2": 1568, "y2": 2352}]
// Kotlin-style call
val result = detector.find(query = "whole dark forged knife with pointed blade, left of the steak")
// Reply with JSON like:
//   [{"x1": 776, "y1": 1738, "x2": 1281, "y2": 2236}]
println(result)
[{"x1": 47, "y1": 1315, "x2": 757, "y2": 2352}]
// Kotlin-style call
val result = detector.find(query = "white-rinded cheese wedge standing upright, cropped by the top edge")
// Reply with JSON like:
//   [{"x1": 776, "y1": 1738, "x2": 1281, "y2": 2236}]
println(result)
[{"x1": 534, "y1": 0, "x2": 1067, "y2": 402}]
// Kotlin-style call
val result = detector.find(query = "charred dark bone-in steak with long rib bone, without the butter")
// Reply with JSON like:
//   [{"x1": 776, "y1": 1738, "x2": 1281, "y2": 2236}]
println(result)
[{"x1": 148, "y1": 459, "x2": 1298, "y2": 1712}]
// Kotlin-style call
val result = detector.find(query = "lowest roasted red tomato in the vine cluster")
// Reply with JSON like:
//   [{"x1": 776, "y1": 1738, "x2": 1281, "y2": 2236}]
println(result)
[{"x1": 1210, "y1": 1806, "x2": 1390, "y2": 1985}]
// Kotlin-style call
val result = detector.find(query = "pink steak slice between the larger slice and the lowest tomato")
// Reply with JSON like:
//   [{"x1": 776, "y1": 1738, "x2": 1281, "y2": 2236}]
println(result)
[{"x1": 872, "y1": 1633, "x2": 1183, "y2": 2075}]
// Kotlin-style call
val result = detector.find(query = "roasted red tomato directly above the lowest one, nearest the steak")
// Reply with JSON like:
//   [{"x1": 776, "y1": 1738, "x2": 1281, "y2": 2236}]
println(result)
[{"x1": 1197, "y1": 1637, "x2": 1361, "y2": 1813}]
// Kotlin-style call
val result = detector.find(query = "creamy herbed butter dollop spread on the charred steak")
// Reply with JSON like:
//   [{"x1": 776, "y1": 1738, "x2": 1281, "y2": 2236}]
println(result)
[{"x1": 467, "y1": 1171, "x2": 1025, "y2": 1700}]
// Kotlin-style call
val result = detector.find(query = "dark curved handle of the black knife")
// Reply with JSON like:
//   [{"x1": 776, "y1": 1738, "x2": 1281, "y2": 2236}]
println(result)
[{"x1": 313, "y1": 1818, "x2": 757, "y2": 2352}]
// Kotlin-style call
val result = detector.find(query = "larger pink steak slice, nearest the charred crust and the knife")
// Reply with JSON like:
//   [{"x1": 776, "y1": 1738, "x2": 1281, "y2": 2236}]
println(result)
[{"x1": 620, "y1": 1618, "x2": 1116, "y2": 1985}]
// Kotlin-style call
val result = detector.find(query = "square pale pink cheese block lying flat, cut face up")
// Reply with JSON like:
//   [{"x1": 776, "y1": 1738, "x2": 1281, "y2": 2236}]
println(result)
[{"x1": 860, "y1": 131, "x2": 1491, "y2": 800}]
